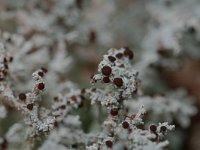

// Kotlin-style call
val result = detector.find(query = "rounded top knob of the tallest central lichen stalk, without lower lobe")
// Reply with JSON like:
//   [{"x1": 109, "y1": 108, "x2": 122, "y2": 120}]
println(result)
[{"x1": 92, "y1": 47, "x2": 139, "y2": 101}]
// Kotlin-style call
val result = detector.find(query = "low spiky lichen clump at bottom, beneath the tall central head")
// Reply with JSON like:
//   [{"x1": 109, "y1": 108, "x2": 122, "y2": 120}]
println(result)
[{"x1": 87, "y1": 107, "x2": 174, "y2": 150}]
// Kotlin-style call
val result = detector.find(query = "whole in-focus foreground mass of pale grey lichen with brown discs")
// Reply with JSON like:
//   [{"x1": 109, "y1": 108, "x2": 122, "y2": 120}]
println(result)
[{"x1": 1, "y1": 48, "x2": 174, "y2": 150}]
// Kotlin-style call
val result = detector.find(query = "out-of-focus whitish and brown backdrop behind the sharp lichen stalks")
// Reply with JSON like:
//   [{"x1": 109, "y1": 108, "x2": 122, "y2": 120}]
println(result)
[{"x1": 0, "y1": 0, "x2": 200, "y2": 150}]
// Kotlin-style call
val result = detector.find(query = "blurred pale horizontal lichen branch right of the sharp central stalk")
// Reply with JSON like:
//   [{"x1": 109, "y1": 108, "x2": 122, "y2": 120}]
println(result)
[{"x1": 125, "y1": 89, "x2": 197, "y2": 128}]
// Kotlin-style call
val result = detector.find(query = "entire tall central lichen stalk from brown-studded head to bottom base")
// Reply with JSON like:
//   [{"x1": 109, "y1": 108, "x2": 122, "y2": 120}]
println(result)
[{"x1": 83, "y1": 47, "x2": 174, "y2": 150}]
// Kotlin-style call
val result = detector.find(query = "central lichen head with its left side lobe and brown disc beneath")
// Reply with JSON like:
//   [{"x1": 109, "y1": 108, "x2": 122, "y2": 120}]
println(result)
[{"x1": 86, "y1": 47, "x2": 139, "y2": 118}]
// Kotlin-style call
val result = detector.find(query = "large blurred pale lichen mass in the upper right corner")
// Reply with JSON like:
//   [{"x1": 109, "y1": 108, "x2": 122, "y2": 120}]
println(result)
[{"x1": 141, "y1": 0, "x2": 200, "y2": 68}]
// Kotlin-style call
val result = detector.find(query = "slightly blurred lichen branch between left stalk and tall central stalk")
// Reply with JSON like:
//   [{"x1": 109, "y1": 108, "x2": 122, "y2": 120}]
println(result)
[{"x1": 39, "y1": 82, "x2": 87, "y2": 150}]
